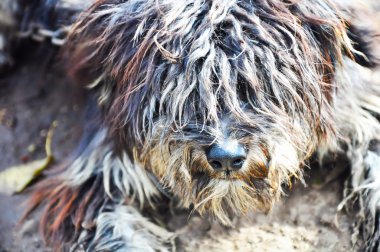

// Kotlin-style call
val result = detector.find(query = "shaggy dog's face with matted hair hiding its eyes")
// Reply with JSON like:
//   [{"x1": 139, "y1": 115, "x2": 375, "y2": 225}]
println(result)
[{"x1": 69, "y1": 0, "x2": 349, "y2": 224}]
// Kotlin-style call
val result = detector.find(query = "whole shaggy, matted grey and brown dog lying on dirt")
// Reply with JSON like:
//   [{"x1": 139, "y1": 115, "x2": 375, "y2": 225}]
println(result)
[{"x1": 0, "y1": 0, "x2": 380, "y2": 251}]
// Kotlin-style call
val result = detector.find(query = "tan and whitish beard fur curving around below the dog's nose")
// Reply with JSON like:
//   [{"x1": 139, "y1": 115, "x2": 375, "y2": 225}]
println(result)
[{"x1": 145, "y1": 133, "x2": 305, "y2": 225}]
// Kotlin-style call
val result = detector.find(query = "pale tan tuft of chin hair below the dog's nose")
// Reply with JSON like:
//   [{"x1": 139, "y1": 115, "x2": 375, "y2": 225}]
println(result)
[{"x1": 192, "y1": 172, "x2": 276, "y2": 226}]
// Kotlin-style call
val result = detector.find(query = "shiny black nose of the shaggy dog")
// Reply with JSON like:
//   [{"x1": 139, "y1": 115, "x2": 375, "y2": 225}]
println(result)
[{"x1": 207, "y1": 140, "x2": 247, "y2": 171}]
